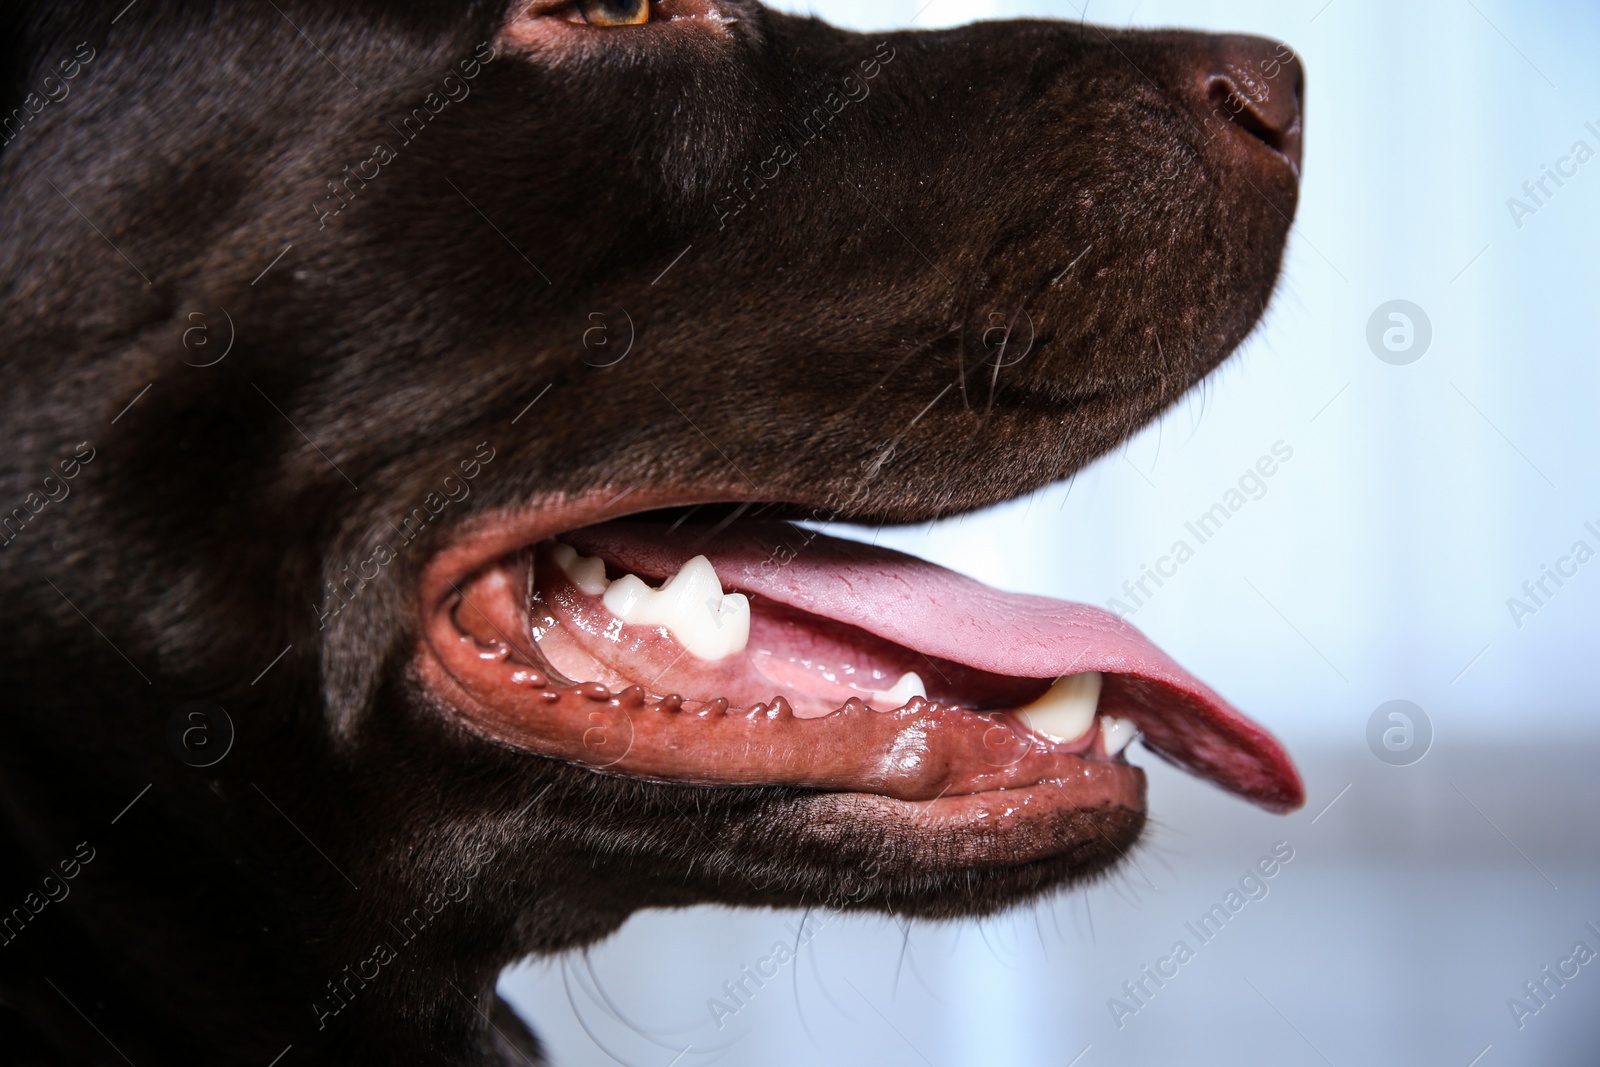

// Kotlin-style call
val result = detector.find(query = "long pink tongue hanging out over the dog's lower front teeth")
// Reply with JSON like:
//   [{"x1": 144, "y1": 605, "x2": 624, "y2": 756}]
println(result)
[{"x1": 560, "y1": 522, "x2": 1306, "y2": 811}]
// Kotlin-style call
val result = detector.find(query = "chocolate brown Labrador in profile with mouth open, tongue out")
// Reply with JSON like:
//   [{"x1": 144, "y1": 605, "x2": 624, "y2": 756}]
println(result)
[{"x1": 0, "y1": 0, "x2": 1302, "y2": 1067}]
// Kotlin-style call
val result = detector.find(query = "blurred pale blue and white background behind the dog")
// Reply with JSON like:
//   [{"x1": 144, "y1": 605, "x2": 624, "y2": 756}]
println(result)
[{"x1": 502, "y1": 0, "x2": 1600, "y2": 1067}]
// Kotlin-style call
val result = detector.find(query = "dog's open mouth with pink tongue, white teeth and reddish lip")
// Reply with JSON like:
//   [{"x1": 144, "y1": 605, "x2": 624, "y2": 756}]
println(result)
[{"x1": 422, "y1": 495, "x2": 1304, "y2": 859}]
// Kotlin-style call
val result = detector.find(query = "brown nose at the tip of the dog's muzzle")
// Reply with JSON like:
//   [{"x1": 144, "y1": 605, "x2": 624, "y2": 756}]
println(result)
[{"x1": 1202, "y1": 34, "x2": 1306, "y2": 174}]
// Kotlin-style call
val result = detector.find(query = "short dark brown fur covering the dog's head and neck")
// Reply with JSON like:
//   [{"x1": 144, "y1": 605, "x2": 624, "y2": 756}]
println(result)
[{"x1": 0, "y1": 0, "x2": 1294, "y2": 1067}]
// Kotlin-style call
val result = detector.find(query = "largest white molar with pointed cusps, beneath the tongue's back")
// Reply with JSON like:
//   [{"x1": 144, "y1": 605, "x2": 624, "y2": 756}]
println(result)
[{"x1": 600, "y1": 555, "x2": 750, "y2": 659}]
